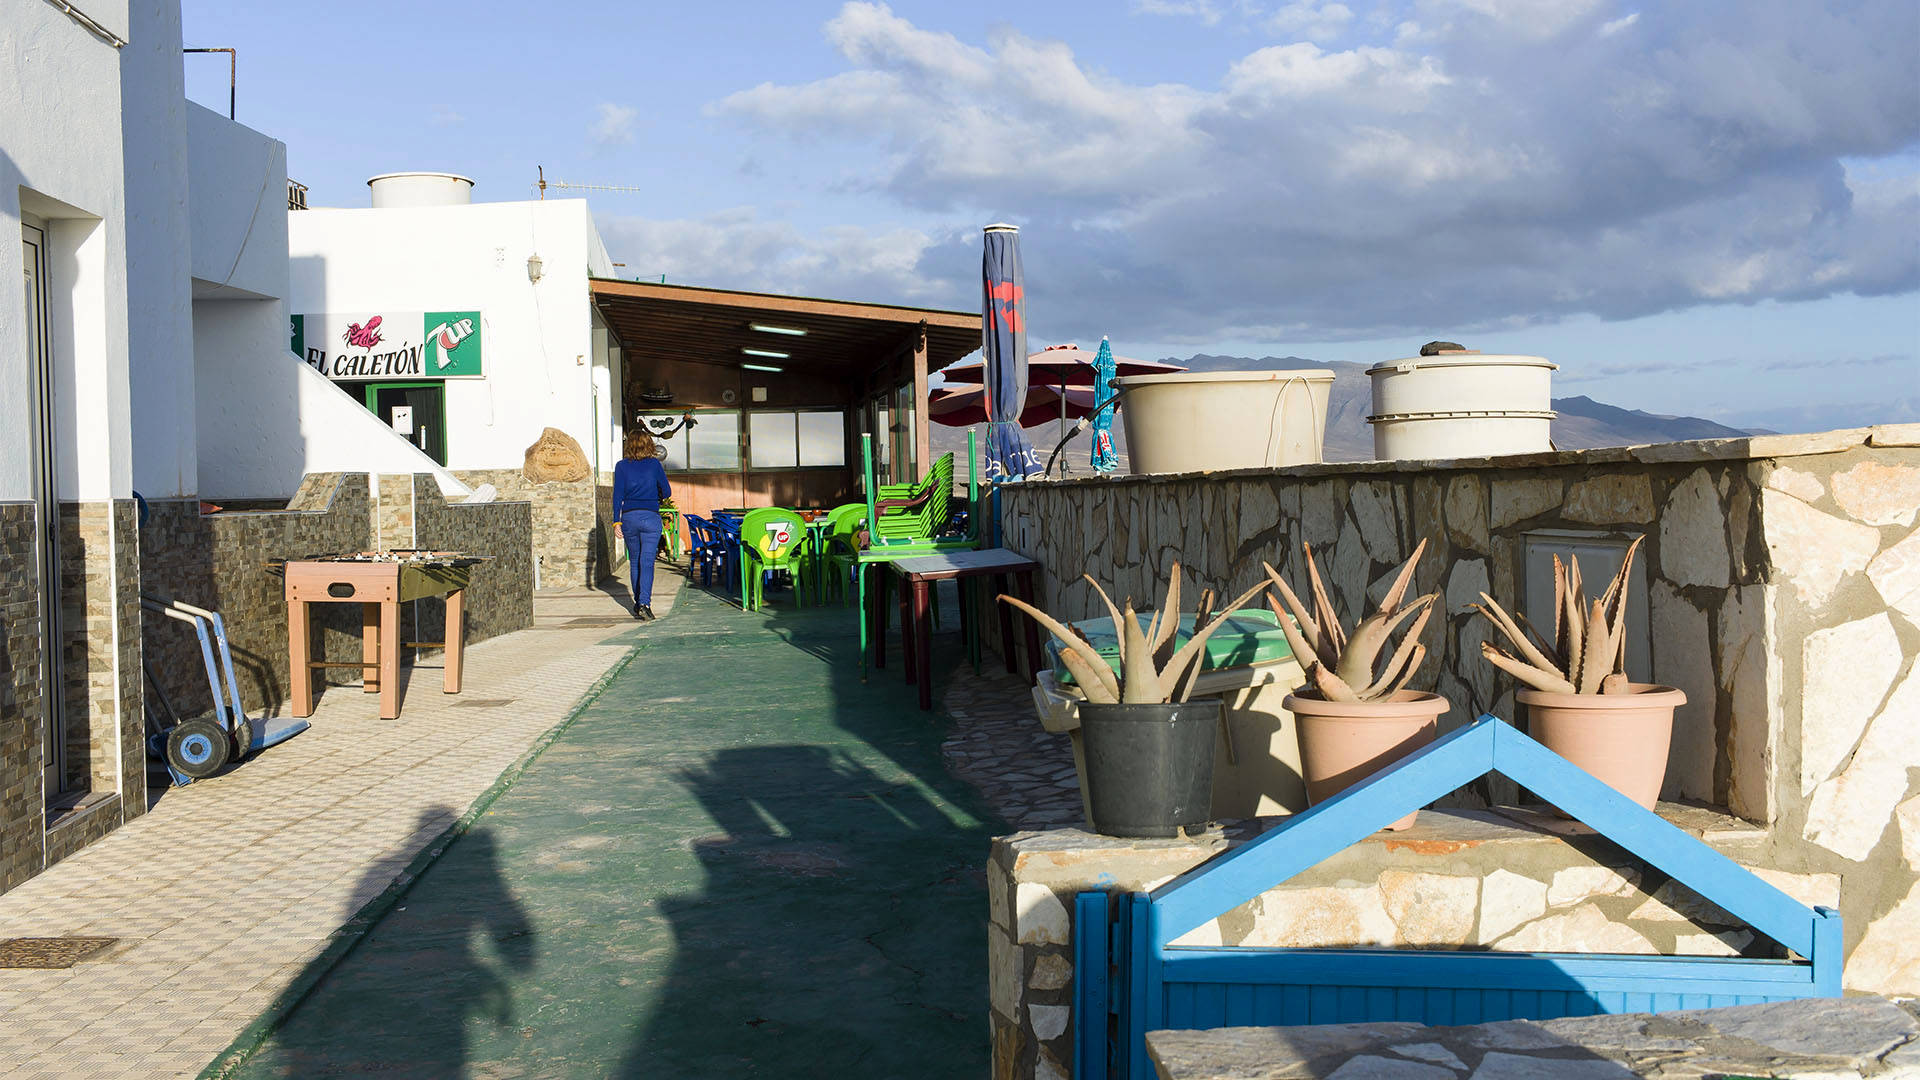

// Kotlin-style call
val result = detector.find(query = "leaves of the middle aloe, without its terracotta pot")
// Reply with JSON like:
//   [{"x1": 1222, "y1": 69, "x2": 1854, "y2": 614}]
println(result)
[{"x1": 1261, "y1": 540, "x2": 1440, "y2": 701}]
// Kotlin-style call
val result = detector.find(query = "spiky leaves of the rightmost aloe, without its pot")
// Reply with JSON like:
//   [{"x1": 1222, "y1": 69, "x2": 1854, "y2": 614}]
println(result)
[{"x1": 1473, "y1": 538, "x2": 1640, "y2": 694}]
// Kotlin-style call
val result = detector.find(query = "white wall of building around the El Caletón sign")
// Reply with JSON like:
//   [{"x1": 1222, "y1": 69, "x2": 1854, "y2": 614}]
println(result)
[{"x1": 288, "y1": 200, "x2": 612, "y2": 469}]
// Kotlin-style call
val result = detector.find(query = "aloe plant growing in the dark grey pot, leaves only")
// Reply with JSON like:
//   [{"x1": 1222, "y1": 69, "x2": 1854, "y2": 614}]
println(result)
[{"x1": 1000, "y1": 563, "x2": 1267, "y2": 705}]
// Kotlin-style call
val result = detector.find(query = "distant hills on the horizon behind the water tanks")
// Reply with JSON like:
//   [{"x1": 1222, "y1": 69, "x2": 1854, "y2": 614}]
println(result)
[{"x1": 933, "y1": 354, "x2": 1763, "y2": 466}]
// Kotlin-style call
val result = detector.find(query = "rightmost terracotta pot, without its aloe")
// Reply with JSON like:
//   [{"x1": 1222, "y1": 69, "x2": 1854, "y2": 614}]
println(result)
[{"x1": 1517, "y1": 682, "x2": 1686, "y2": 809}]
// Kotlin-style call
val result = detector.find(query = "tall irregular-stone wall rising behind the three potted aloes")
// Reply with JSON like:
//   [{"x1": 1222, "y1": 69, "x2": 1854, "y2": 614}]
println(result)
[{"x1": 1002, "y1": 425, "x2": 1920, "y2": 994}]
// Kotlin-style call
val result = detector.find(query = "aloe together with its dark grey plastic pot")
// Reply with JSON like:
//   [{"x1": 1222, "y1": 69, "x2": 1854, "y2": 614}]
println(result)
[{"x1": 1000, "y1": 563, "x2": 1267, "y2": 836}]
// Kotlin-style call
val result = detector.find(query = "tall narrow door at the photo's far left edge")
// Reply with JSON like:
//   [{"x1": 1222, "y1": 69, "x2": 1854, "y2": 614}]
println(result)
[{"x1": 21, "y1": 225, "x2": 67, "y2": 801}]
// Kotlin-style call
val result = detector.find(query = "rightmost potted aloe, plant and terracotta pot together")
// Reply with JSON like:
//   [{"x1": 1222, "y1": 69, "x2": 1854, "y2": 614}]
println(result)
[{"x1": 1475, "y1": 538, "x2": 1686, "y2": 809}]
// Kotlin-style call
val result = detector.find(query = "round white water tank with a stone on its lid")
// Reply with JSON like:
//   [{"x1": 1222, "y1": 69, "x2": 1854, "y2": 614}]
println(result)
[{"x1": 1367, "y1": 352, "x2": 1557, "y2": 461}]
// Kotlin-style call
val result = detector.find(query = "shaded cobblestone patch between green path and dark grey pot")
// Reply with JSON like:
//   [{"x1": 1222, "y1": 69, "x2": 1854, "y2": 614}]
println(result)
[{"x1": 941, "y1": 655, "x2": 1083, "y2": 830}]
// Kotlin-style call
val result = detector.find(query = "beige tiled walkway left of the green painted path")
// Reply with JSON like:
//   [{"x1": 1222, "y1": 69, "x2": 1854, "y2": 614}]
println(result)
[{"x1": 0, "y1": 569, "x2": 682, "y2": 1080}]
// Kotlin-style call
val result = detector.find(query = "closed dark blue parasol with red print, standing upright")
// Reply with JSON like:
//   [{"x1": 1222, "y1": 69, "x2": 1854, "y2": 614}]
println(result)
[{"x1": 981, "y1": 225, "x2": 1043, "y2": 480}]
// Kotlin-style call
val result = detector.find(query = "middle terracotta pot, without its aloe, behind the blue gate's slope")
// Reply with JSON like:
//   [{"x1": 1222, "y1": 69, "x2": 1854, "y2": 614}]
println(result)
[{"x1": 1283, "y1": 690, "x2": 1448, "y2": 832}]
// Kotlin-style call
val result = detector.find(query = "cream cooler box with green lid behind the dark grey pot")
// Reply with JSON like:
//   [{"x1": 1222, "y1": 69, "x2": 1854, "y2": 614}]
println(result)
[{"x1": 1033, "y1": 607, "x2": 1308, "y2": 821}]
